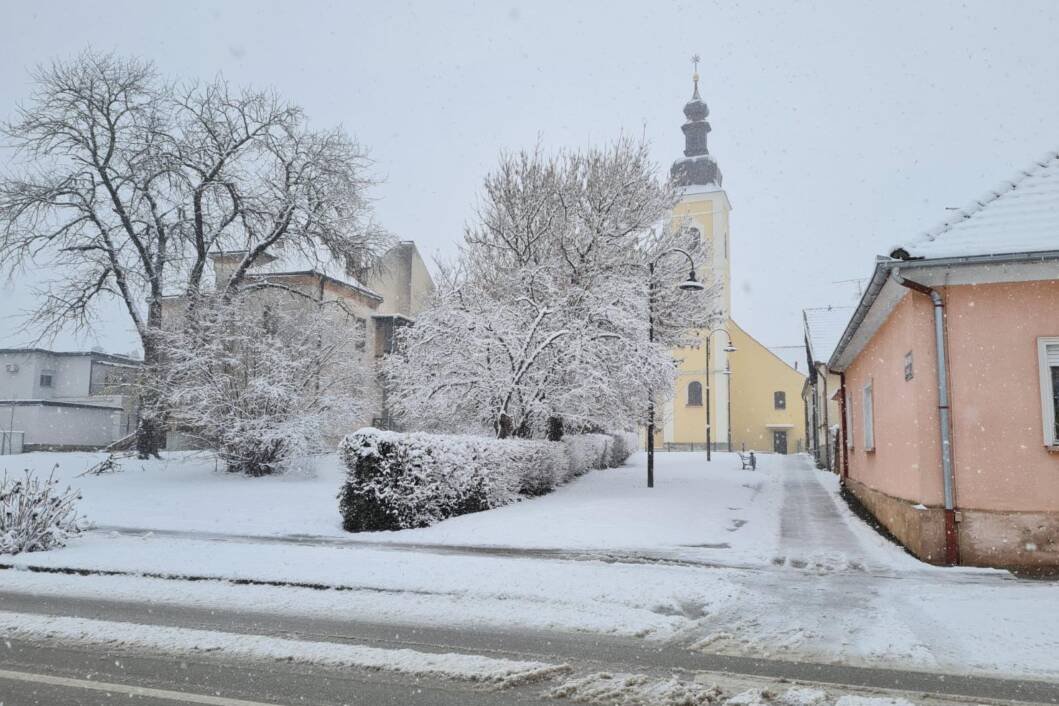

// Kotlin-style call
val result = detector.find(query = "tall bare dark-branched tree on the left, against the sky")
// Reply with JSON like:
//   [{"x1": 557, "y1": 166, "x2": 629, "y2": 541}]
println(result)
[{"x1": 0, "y1": 52, "x2": 387, "y2": 456}]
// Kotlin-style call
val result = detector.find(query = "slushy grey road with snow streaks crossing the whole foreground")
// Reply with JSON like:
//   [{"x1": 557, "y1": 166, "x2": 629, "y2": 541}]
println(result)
[{"x1": 0, "y1": 593, "x2": 1059, "y2": 706}]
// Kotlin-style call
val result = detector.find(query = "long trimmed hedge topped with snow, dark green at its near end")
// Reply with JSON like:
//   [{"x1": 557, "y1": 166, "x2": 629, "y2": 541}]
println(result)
[{"x1": 339, "y1": 428, "x2": 632, "y2": 531}]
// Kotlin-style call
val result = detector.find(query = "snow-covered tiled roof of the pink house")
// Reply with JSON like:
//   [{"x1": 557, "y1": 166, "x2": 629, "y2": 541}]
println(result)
[{"x1": 892, "y1": 151, "x2": 1059, "y2": 259}]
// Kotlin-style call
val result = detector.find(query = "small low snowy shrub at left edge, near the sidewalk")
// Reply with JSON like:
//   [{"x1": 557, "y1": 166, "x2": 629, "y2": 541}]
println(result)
[{"x1": 0, "y1": 470, "x2": 80, "y2": 554}]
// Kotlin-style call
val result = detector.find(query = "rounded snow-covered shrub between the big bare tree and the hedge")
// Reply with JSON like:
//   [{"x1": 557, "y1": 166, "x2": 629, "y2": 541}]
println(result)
[{"x1": 159, "y1": 287, "x2": 365, "y2": 476}]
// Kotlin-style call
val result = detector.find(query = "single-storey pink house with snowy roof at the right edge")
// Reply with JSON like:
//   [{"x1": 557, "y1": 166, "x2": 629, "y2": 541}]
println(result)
[{"x1": 829, "y1": 153, "x2": 1059, "y2": 568}]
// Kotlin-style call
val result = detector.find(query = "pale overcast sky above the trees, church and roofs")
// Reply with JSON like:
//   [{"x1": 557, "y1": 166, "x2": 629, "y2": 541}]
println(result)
[{"x1": 0, "y1": 0, "x2": 1059, "y2": 351}]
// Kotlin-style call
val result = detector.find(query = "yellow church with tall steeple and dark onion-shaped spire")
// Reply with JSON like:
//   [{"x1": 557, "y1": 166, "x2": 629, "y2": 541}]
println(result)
[{"x1": 654, "y1": 72, "x2": 806, "y2": 453}]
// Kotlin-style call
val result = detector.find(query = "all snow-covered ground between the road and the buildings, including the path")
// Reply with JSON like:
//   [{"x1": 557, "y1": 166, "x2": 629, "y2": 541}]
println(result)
[{"x1": 0, "y1": 454, "x2": 1059, "y2": 678}]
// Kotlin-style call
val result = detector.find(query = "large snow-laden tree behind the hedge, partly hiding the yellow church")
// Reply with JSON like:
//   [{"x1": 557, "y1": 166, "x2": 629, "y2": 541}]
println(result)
[{"x1": 388, "y1": 140, "x2": 716, "y2": 438}]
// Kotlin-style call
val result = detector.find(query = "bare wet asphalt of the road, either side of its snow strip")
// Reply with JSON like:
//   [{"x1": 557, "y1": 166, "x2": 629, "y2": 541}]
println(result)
[{"x1": 0, "y1": 592, "x2": 1059, "y2": 706}]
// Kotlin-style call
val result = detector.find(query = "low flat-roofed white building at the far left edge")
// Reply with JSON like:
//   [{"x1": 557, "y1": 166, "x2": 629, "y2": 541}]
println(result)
[{"x1": 0, "y1": 348, "x2": 140, "y2": 453}]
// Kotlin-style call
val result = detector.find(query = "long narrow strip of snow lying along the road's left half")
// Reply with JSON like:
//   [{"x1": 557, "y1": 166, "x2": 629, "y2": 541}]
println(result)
[{"x1": 0, "y1": 612, "x2": 570, "y2": 688}]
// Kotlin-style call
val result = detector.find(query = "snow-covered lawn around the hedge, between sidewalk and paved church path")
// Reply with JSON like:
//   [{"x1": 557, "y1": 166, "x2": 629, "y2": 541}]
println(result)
[{"x1": 0, "y1": 452, "x2": 782, "y2": 559}]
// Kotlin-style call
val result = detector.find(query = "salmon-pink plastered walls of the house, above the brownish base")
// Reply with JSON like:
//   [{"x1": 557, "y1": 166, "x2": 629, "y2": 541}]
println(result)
[{"x1": 846, "y1": 280, "x2": 1059, "y2": 512}]
